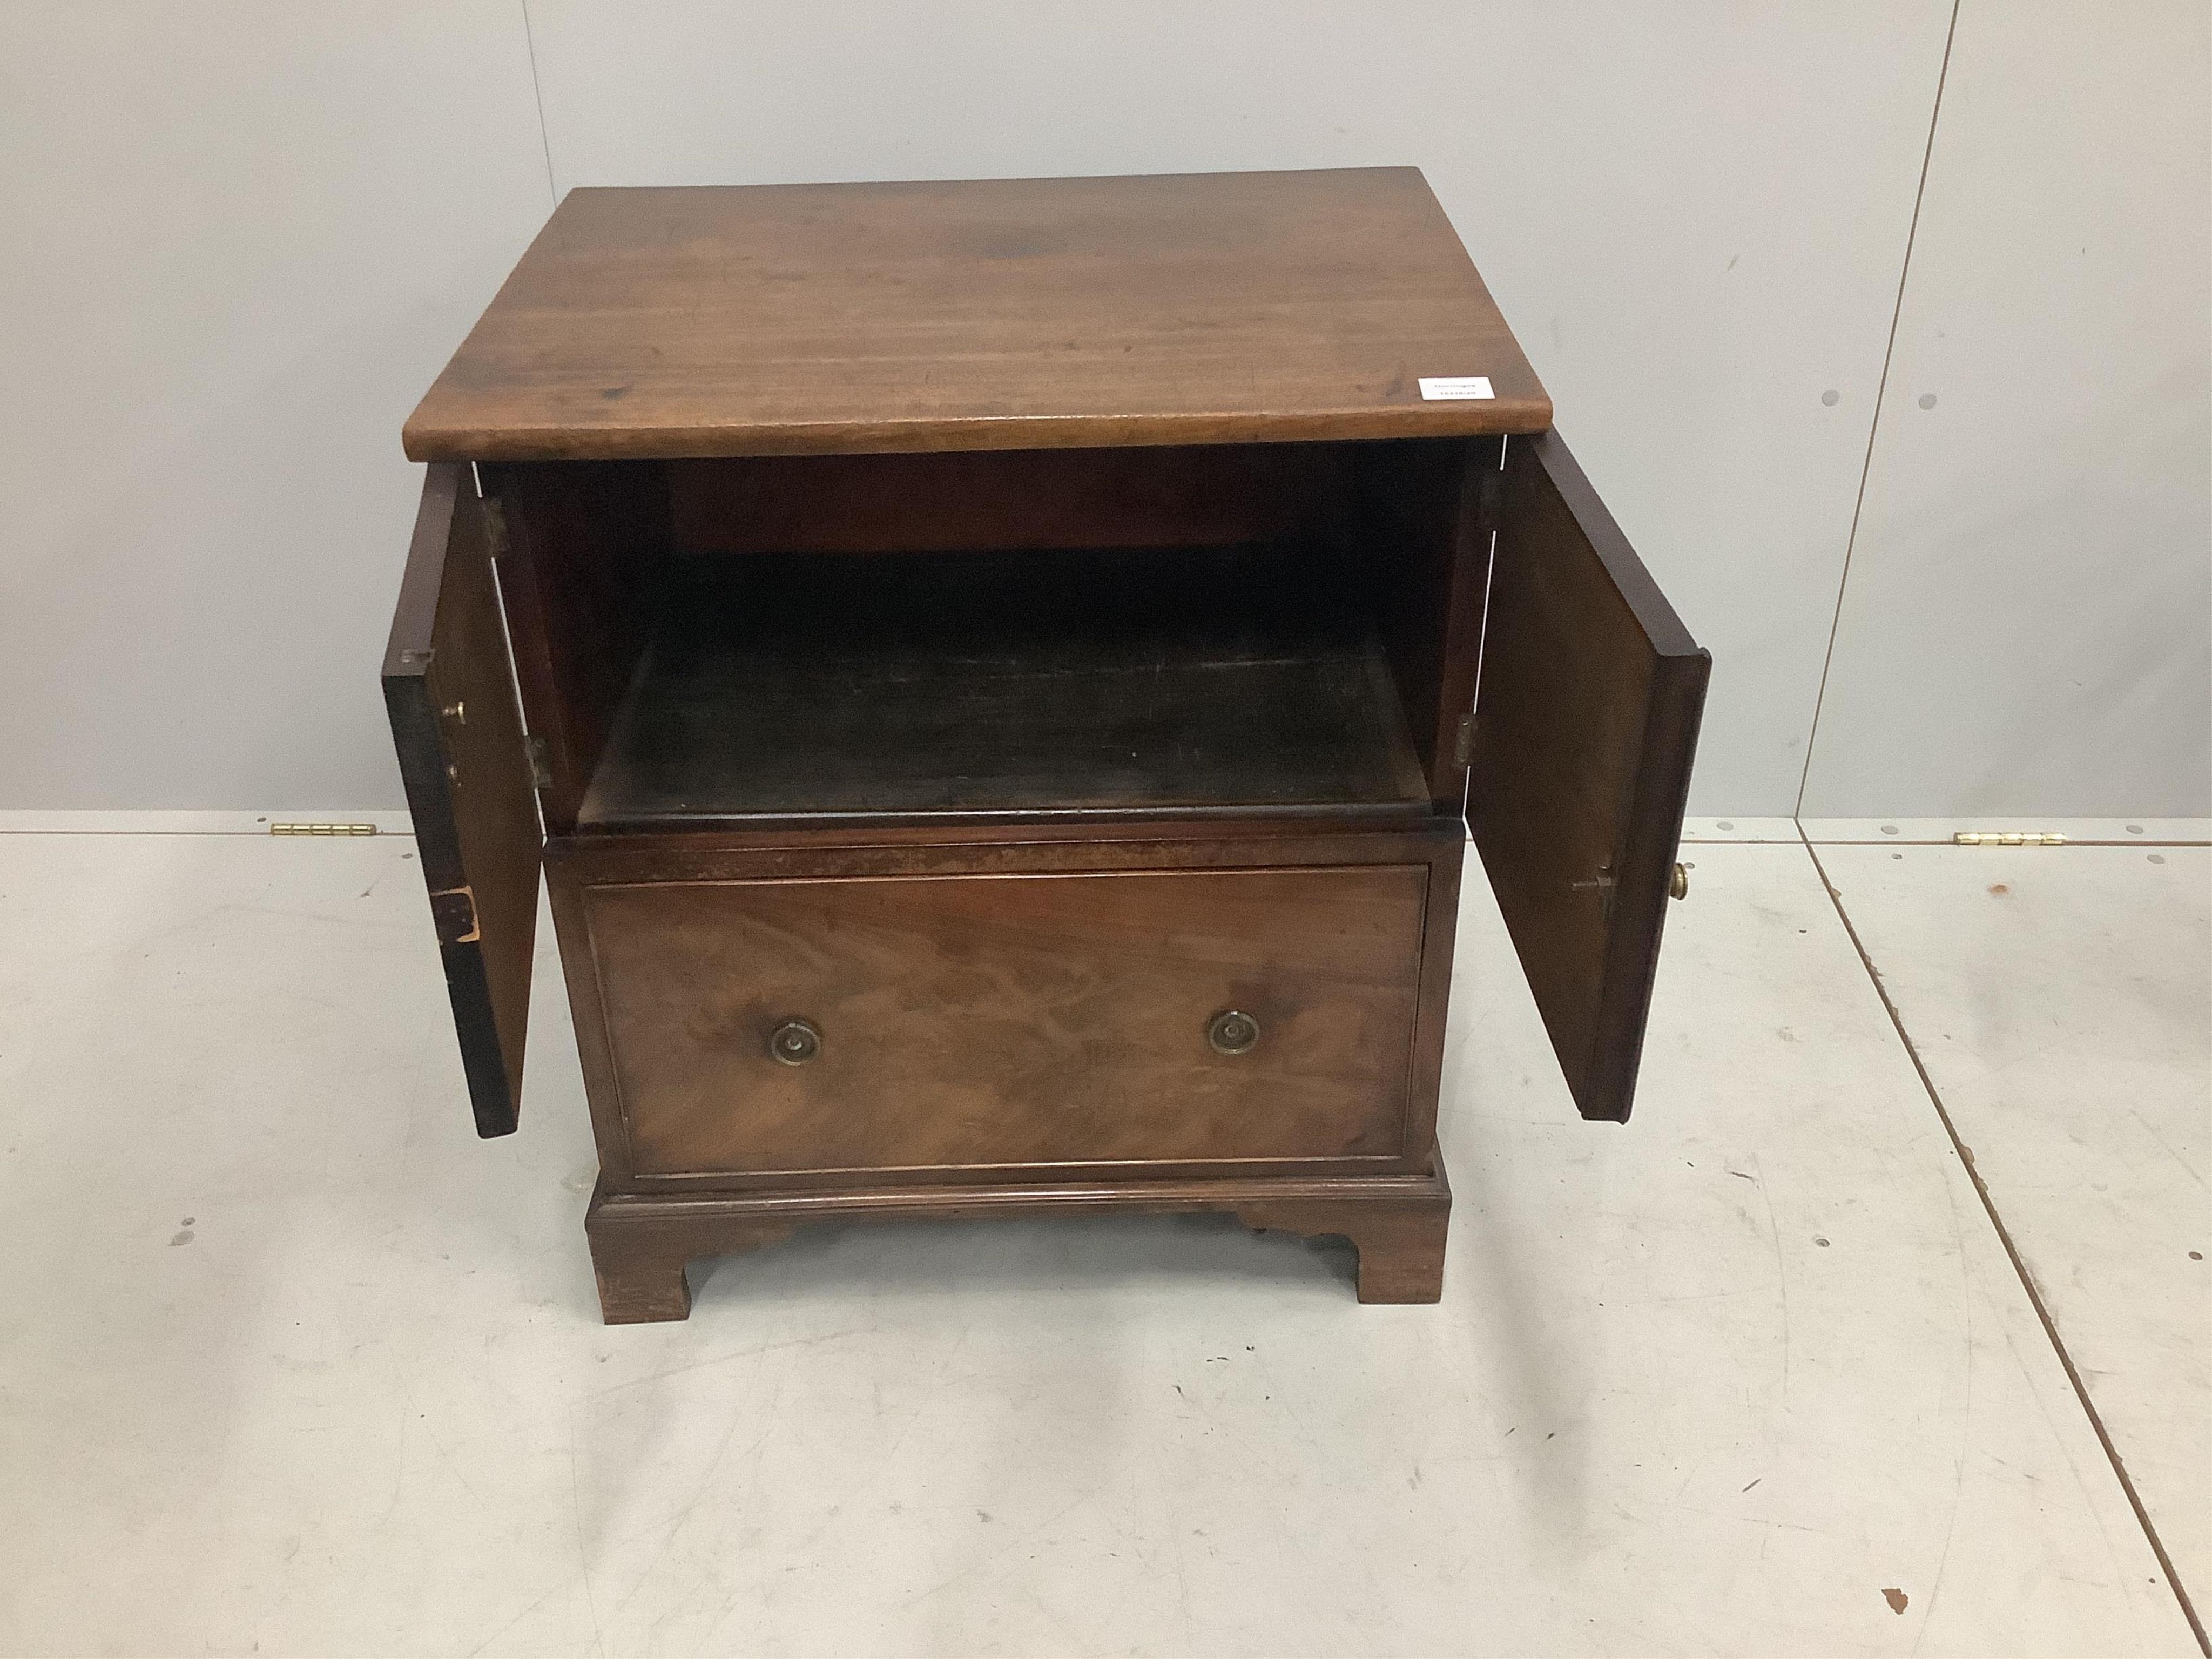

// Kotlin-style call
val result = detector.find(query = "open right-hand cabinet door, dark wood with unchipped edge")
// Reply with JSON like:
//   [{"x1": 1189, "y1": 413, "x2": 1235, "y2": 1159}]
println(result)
[{"x1": 1467, "y1": 431, "x2": 1712, "y2": 1122}]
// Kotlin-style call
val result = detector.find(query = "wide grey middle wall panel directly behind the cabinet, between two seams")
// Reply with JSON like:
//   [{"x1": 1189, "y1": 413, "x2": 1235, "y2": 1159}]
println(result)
[{"x1": 531, "y1": 0, "x2": 1949, "y2": 814}]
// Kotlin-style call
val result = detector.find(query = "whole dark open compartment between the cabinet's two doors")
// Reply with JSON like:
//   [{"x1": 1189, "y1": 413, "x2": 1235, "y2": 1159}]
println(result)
[{"x1": 484, "y1": 440, "x2": 1478, "y2": 830}]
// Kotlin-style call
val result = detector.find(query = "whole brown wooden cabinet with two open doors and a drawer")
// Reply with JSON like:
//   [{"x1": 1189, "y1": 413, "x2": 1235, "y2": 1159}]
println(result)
[{"x1": 383, "y1": 168, "x2": 1708, "y2": 1320}]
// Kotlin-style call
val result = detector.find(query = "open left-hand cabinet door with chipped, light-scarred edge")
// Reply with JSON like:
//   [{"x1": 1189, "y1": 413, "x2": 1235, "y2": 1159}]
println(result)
[{"x1": 385, "y1": 462, "x2": 544, "y2": 1137}]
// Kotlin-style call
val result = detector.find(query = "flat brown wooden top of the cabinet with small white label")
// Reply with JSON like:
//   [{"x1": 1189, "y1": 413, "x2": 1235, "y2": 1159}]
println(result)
[{"x1": 405, "y1": 168, "x2": 1550, "y2": 460}]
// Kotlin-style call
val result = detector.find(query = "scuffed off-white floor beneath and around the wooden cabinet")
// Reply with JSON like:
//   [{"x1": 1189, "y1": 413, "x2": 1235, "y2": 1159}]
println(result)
[{"x1": 0, "y1": 823, "x2": 2212, "y2": 1659}]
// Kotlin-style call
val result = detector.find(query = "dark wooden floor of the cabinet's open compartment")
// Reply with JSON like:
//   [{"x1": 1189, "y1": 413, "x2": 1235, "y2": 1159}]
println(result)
[{"x1": 579, "y1": 547, "x2": 1429, "y2": 830}]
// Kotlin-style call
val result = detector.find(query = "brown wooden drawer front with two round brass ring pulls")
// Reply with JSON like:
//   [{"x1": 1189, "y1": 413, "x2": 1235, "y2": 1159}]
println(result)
[{"x1": 579, "y1": 865, "x2": 1429, "y2": 1177}]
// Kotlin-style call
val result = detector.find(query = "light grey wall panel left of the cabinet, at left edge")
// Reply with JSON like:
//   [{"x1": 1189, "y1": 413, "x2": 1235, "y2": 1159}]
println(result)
[{"x1": 0, "y1": 0, "x2": 551, "y2": 807}]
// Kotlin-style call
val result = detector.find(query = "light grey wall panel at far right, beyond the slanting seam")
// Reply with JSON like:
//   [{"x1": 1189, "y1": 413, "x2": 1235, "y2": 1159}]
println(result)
[{"x1": 1803, "y1": 0, "x2": 2212, "y2": 816}]
